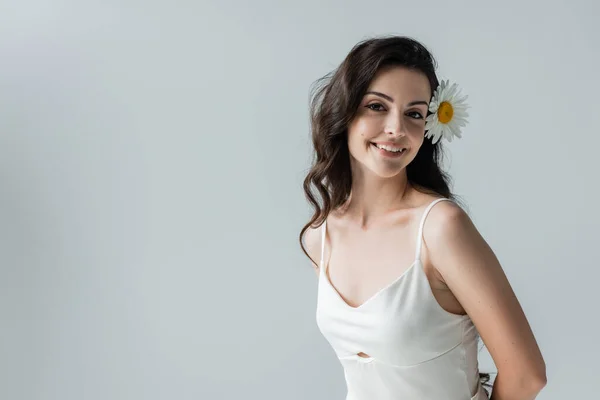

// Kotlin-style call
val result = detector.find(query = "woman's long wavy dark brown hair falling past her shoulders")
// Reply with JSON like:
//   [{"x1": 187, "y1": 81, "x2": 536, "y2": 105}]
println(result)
[{"x1": 298, "y1": 36, "x2": 491, "y2": 395}]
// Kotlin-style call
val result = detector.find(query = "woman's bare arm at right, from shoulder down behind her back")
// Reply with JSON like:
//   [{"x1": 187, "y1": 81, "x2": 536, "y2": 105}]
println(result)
[{"x1": 423, "y1": 202, "x2": 546, "y2": 400}]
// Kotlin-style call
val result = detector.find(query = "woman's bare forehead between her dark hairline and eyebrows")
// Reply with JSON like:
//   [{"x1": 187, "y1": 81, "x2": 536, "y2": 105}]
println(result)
[{"x1": 368, "y1": 66, "x2": 431, "y2": 101}]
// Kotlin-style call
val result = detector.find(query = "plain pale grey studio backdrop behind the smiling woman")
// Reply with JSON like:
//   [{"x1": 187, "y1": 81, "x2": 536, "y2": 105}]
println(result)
[{"x1": 0, "y1": 0, "x2": 600, "y2": 400}]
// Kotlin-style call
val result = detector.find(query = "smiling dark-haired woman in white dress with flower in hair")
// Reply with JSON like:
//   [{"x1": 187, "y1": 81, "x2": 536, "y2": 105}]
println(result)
[{"x1": 299, "y1": 36, "x2": 546, "y2": 400}]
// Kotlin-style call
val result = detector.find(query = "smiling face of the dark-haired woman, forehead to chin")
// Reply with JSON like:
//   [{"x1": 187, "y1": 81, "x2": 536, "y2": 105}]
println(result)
[{"x1": 348, "y1": 66, "x2": 431, "y2": 177}]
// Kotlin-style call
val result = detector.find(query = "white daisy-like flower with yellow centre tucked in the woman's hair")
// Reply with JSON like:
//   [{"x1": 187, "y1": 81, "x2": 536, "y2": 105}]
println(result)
[{"x1": 425, "y1": 80, "x2": 469, "y2": 143}]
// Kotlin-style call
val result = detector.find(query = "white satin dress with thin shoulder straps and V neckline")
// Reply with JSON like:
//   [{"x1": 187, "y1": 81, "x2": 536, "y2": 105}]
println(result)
[{"x1": 316, "y1": 198, "x2": 488, "y2": 400}]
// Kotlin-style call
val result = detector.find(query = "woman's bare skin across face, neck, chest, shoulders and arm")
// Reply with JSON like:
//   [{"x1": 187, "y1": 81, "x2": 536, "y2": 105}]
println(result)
[{"x1": 304, "y1": 67, "x2": 546, "y2": 400}]
